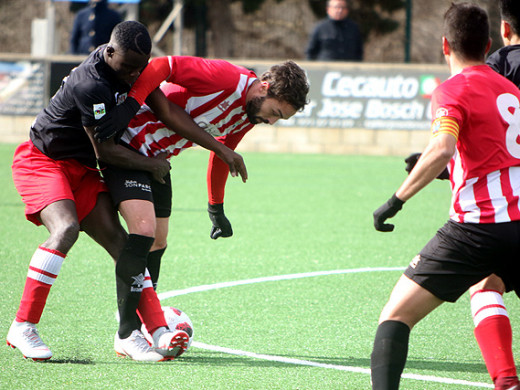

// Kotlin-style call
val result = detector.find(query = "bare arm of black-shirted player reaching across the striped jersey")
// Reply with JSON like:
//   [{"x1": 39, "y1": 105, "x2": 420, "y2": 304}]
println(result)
[{"x1": 146, "y1": 88, "x2": 247, "y2": 183}]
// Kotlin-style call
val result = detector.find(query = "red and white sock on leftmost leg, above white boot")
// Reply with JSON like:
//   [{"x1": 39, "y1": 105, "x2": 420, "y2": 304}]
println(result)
[{"x1": 16, "y1": 246, "x2": 65, "y2": 324}]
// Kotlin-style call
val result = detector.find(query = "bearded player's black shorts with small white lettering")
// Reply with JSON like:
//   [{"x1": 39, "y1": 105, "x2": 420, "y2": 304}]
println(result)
[{"x1": 102, "y1": 165, "x2": 172, "y2": 218}]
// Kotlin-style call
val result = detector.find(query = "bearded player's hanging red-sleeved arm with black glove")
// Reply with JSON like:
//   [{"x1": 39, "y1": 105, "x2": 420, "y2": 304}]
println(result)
[{"x1": 206, "y1": 131, "x2": 246, "y2": 240}]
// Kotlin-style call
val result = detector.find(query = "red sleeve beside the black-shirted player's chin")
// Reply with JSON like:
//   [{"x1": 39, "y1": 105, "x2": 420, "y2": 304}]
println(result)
[{"x1": 128, "y1": 57, "x2": 173, "y2": 106}]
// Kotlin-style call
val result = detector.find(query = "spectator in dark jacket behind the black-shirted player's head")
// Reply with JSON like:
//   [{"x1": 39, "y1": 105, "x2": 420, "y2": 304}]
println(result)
[{"x1": 70, "y1": 0, "x2": 121, "y2": 54}]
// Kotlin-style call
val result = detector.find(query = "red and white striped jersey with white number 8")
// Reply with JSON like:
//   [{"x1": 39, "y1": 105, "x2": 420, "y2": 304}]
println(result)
[{"x1": 432, "y1": 65, "x2": 520, "y2": 223}]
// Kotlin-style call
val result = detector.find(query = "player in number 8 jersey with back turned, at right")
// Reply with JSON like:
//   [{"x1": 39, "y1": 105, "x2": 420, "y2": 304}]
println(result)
[{"x1": 371, "y1": 3, "x2": 520, "y2": 390}]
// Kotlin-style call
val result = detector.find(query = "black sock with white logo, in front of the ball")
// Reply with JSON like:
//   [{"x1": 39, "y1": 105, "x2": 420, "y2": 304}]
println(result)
[{"x1": 116, "y1": 234, "x2": 154, "y2": 339}]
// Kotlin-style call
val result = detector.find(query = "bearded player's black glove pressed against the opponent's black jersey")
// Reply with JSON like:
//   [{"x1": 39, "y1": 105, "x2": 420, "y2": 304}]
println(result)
[{"x1": 94, "y1": 97, "x2": 141, "y2": 142}]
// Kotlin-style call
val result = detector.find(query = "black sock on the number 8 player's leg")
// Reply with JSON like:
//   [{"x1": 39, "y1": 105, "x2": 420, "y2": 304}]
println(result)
[{"x1": 370, "y1": 321, "x2": 410, "y2": 390}]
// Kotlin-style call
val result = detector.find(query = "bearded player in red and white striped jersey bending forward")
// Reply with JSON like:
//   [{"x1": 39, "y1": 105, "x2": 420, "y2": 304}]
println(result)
[{"x1": 97, "y1": 56, "x2": 309, "y2": 314}]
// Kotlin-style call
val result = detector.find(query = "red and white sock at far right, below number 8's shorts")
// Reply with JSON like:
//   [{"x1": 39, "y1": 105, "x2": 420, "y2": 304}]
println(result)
[{"x1": 471, "y1": 290, "x2": 516, "y2": 382}]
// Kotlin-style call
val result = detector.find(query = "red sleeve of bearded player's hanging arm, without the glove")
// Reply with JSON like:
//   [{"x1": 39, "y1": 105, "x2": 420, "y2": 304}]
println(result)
[{"x1": 206, "y1": 130, "x2": 249, "y2": 204}]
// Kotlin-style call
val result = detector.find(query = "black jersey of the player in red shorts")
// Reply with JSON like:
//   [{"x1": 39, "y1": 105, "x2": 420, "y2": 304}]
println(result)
[{"x1": 30, "y1": 45, "x2": 130, "y2": 167}]
